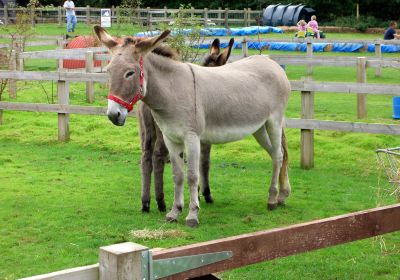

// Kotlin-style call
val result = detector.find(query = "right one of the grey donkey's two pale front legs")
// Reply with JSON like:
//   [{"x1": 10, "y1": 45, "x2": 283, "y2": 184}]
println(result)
[{"x1": 185, "y1": 133, "x2": 200, "y2": 227}]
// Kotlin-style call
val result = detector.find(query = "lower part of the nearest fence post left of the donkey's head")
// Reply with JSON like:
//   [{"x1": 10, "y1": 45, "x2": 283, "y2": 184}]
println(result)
[{"x1": 57, "y1": 81, "x2": 69, "y2": 142}]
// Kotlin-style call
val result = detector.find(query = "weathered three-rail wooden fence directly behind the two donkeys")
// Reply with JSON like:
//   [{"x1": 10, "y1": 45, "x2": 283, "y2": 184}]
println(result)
[{"x1": 0, "y1": 40, "x2": 400, "y2": 169}]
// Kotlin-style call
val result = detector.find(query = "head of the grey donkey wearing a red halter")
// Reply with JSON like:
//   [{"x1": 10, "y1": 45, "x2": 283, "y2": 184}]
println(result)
[{"x1": 94, "y1": 26, "x2": 170, "y2": 126}]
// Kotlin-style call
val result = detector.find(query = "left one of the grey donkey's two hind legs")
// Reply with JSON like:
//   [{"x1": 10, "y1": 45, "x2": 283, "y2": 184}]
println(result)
[{"x1": 266, "y1": 120, "x2": 283, "y2": 210}]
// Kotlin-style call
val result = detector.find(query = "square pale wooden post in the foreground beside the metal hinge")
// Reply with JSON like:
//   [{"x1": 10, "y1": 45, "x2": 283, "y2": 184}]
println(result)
[{"x1": 99, "y1": 242, "x2": 149, "y2": 280}]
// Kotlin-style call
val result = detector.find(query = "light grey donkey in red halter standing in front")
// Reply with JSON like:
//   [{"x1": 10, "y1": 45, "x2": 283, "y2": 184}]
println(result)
[{"x1": 94, "y1": 26, "x2": 290, "y2": 227}]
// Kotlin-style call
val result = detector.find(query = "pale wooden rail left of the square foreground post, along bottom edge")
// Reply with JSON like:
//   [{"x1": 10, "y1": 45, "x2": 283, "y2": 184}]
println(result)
[{"x1": 20, "y1": 263, "x2": 99, "y2": 280}]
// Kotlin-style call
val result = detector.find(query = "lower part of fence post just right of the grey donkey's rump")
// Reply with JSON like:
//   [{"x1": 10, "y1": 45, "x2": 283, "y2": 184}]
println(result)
[{"x1": 300, "y1": 91, "x2": 314, "y2": 169}]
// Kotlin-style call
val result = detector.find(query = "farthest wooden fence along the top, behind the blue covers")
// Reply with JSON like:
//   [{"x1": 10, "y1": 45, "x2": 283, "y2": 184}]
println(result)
[{"x1": 0, "y1": 6, "x2": 262, "y2": 27}]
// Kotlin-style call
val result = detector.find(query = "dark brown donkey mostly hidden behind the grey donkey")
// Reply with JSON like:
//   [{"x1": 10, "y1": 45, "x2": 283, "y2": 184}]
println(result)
[{"x1": 138, "y1": 38, "x2": 234, "y2": 212}]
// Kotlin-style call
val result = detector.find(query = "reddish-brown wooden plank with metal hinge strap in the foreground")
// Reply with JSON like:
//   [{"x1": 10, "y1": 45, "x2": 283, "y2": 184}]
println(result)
[{"x1": 153, "y1": 204, "x2": 400, "y2": 279}]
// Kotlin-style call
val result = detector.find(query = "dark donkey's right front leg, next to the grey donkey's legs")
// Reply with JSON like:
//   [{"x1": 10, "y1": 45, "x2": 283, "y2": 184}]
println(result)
[{"x1": 153, "y1": 127, "x2": 168, "y2": 212}]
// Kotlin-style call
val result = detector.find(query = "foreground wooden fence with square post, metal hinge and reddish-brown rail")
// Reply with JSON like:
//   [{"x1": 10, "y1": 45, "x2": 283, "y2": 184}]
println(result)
[{"x1": 20, "y1": 204, "x2": 400, "y2": 280}]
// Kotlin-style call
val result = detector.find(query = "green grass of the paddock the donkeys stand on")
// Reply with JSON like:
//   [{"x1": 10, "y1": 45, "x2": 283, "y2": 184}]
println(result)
[{"x1": 0, "y1": 24, "x2": 400, "y2": 279}]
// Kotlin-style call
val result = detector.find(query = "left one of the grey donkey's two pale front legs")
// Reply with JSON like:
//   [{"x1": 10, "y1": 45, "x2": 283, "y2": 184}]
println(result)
[{"x1": 164, "y1": 137, "x2": 184, "y2": 222}]
